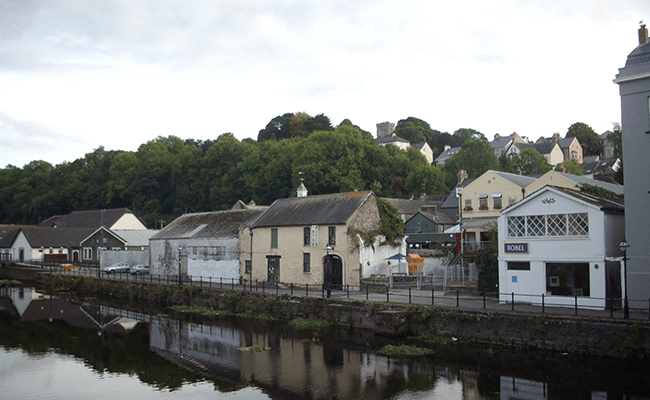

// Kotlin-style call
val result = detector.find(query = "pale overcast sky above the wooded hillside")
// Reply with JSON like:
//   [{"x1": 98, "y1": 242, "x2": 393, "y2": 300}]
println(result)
[{"x1": 0, "y1": 0, "x2": 650, "y2": 167}]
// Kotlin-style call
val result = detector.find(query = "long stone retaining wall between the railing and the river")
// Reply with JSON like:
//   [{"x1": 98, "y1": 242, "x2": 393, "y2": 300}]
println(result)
[{"x1": 29, "y1": 276, "x2": 650, "y2": 358}]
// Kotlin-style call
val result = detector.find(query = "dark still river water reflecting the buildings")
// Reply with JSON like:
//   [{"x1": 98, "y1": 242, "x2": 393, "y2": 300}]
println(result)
[{"x1": 0, "y1": 287, "x2": 650, "y2": 400}]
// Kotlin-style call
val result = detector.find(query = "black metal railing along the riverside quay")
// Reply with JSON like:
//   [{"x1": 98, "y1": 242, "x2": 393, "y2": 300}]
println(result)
[{"x1": 19, "y1": 263, "x2": 650, "y2": 320}]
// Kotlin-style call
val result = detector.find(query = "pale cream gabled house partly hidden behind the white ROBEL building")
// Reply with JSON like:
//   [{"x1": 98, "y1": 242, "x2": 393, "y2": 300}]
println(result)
[{"x1": 459, "y1": 170, "x2": 535, "y2": 252}]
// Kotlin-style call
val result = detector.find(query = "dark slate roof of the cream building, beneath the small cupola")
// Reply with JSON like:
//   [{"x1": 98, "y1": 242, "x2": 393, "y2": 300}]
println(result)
[{"x1": 253, "y1": 190, "x2": 373, "y2": 228}]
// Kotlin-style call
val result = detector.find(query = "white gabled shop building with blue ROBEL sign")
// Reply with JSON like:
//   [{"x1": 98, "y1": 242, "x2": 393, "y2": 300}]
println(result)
[{"x1": 499, "y1": 186, "x2": 625, "y2": 309}]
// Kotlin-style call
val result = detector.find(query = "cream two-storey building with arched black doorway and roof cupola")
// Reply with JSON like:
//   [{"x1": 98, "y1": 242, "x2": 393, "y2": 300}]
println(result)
[{"x1": 248, "y1": 190, "x2": 388, "y2": 288}]
